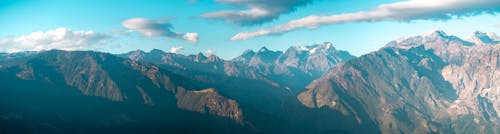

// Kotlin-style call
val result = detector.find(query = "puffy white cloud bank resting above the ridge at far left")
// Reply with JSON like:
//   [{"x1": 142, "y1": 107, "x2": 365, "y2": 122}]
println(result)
[{"x1": 0, "y1": 28, "x2": 111, "y2": 53}]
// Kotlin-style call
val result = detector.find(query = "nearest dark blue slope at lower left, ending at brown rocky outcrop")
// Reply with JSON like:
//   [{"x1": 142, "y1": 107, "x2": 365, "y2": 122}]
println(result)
[{"x1": 0, "y1": 50, "x2": 251, "y2": 133}]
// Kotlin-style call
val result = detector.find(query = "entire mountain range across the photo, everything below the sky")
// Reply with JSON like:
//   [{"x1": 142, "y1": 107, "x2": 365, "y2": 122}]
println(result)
[{"x1": 0, "y1": 31, "x2": 500, "y2": 133}]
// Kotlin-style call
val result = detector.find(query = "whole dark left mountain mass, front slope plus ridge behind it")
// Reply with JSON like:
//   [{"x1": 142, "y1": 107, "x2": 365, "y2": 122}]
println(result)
[{"x1": 0, "y1": 43, "x2": 360, "y2": 133}]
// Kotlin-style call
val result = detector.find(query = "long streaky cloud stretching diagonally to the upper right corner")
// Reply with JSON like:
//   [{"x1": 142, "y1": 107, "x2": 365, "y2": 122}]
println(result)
[{"x1": 231, "y1": 0, "x2": 500, "y2": 40}]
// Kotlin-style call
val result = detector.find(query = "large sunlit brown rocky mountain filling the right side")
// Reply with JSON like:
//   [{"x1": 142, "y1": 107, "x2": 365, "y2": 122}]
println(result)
[{"x1": 298, "y1": 31, "x2": 500, "y2": 133}]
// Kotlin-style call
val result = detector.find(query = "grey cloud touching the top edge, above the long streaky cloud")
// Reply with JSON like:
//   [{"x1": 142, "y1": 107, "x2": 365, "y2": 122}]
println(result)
[{"x1": 201, "y1": 0, "x2": 312, "y2": 26}]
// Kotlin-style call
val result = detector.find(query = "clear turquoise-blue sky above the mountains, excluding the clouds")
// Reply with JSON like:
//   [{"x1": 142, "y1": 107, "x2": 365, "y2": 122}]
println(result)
[{"x1": 0, "y1": 0, "x2": 500, "y2": 59}]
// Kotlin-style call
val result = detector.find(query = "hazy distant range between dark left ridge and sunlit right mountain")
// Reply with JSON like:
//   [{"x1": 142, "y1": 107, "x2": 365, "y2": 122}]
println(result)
[{"x1": 119, "y1": 42, "x2": 355, "y2": 93}]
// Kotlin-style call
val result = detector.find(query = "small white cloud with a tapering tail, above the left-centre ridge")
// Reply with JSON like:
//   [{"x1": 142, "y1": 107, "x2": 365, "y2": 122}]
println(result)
[{"x1": 122, "y1": 18, "x2": 198, "y2": 43}]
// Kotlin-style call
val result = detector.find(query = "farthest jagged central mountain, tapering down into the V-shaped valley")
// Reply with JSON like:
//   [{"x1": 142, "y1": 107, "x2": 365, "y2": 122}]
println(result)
[{"x1": 233, "y1": 42, "x2": 355, "y2": 93}]
